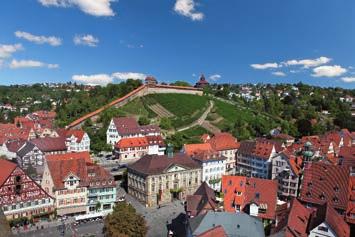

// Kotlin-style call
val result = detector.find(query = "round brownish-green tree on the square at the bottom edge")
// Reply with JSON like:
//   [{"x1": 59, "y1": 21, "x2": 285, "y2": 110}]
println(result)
[{"x1": 104, "y1": 202, "x2": 148, "y2": 237}]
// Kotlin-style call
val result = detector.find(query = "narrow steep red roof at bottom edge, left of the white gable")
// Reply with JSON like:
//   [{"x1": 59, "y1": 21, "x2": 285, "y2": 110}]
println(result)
[{"x1": 285, "y1": 198, "x2": 313, "y2": 237}]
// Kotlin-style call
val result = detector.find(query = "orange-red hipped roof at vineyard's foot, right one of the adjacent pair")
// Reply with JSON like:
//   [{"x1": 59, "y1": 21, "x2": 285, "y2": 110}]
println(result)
[{"x1": 207, "y1": 133, "x2": 240, "y2": 151}]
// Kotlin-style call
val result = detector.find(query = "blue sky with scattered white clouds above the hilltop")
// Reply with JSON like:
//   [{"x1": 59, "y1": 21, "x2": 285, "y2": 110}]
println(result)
[{"x1": 0, "y1": 0, "x2": 355, "y2": 88}]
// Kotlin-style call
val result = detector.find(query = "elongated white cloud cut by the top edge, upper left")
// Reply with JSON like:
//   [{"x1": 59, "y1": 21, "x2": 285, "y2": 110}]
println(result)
[{"x1": 38, "y1": 0, "x2": 118, "y2": 16}]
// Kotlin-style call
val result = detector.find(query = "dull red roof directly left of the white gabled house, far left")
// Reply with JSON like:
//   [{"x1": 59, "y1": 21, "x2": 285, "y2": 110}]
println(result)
[{"x1": 30, "y1": 137, "x2": 67, "y2": 152}]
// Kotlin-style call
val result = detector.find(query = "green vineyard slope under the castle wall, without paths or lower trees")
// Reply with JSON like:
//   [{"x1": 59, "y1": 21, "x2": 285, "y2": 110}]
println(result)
[{"x1": 120, "y1": 94, "x2": 289, "y2": 139}]
